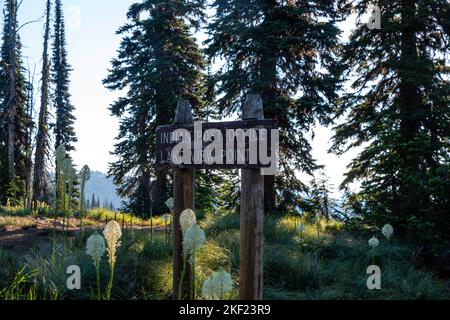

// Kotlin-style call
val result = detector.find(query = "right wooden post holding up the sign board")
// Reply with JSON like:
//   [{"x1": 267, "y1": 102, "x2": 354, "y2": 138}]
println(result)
[{"x1": 239, "y1": 94, "x2": 264, "y2": 300}]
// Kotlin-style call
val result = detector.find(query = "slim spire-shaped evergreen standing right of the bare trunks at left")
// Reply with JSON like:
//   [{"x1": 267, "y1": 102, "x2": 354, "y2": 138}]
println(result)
[{"x1": 51, "y1": 0, "x2": 77, "y2": 153}]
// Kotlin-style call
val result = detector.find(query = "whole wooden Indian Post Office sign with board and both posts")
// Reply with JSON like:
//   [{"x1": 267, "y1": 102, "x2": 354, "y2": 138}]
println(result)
[{"x1": 163, "y1": 95, "x2": 272, "y2": 300}]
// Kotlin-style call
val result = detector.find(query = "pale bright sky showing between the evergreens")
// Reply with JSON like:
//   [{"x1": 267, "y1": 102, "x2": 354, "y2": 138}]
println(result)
[{"x1": 14, "y1": 0, "x2": 364, "y2": 196}]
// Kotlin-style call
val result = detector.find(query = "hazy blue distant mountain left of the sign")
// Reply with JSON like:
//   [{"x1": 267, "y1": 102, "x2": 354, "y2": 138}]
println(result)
[{"x1": 85, "y1": 171, "x2": 124, "y2": 209}]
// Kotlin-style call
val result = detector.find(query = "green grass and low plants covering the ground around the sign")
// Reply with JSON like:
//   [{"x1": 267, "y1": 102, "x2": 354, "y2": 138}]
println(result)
[{"x1": 0, "y1": 210, "x2": 450, "y2": 300}]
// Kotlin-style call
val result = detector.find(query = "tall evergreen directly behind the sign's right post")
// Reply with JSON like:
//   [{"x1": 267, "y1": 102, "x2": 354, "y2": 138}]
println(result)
[{"x1": 206, "y1": 0, "x2": 339, "y2": 212}]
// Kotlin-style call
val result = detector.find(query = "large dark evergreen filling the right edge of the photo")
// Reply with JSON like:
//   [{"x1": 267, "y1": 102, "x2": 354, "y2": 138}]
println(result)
[{"x1": 333, "y1": 0, "x2": 450, "y2": 248}]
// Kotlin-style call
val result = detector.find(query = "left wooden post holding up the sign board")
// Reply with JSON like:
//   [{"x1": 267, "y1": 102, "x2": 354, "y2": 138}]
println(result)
[{"x1": 173, "y1": 100, "x2": 195, "y2": 300}]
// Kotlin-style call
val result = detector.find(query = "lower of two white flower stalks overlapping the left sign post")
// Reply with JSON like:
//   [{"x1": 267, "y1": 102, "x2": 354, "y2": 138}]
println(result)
[{"x1": 178, "y1": 222, "x2": 206, "y2": 300}]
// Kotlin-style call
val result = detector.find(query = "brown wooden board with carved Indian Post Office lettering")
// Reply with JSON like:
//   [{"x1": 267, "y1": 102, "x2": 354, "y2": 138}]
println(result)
[{"x1": 156, "y1": 119, "x2": 275, "y2": 169}]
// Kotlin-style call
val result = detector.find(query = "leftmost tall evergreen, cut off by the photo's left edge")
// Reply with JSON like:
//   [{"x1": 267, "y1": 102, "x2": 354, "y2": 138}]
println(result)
[{"x1": 0, "y1": 0, "x2": 31, "y2": 205}]
